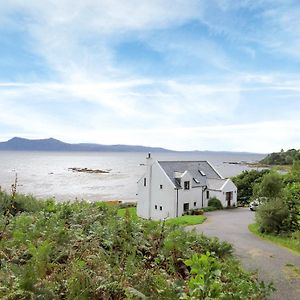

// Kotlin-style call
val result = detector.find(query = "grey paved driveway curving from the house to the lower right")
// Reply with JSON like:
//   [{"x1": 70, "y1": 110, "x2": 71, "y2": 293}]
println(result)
[{"x1": 191, "y1": 208, "x2": 300, "y2": 300}]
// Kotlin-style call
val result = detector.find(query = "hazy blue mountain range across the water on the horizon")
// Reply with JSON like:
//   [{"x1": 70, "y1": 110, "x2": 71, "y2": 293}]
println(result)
[{"x1": 0, "y1": 137, "x2": 172, "y2": 152}]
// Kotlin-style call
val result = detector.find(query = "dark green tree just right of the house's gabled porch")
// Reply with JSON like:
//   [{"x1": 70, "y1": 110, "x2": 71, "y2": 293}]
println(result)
[{"x1": 232, "y1": 170, "x2": 270, "y2": 204}]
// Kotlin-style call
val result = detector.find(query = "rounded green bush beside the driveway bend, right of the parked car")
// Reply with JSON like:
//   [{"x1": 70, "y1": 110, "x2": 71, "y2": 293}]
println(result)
[{"x1": 256, "y1": 198, "x2": 289, "y2": 234}]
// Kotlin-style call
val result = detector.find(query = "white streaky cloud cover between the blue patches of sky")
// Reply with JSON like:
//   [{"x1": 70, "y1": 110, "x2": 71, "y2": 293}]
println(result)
[{"x1": 0, "y1": 0, "x2": 300, "y2": 152}]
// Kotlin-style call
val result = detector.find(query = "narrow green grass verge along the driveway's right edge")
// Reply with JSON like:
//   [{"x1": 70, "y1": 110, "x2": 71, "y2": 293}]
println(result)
[{"x1": 248, "y1": 224, "x2": 300, "y2": 254}]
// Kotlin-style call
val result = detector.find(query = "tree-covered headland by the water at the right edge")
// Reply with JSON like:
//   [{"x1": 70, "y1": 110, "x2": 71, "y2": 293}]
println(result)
[{"x1": 260, "y1": 149, "x2": 300, "y2": 165}]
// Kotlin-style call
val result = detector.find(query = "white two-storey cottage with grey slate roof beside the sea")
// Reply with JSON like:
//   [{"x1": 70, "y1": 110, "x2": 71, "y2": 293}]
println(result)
[{"x1": 137, "y1": 153, "x2": 237, "y2": 220}]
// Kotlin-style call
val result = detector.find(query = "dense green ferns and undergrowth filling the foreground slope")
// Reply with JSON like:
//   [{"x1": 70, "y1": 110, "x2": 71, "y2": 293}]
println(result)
[{"x1": 0, "y1": 189, "x2": 272, "y2": 300}]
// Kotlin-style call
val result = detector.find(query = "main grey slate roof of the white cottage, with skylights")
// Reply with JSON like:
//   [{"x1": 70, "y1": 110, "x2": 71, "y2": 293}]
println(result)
[{"x1": 158, "y1": 161, "x2": 225, "y2": 188}]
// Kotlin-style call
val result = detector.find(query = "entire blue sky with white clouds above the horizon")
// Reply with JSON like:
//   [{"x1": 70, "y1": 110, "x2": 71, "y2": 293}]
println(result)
[{"x1": 0, "y1": 0, "x2": 300, "y2": 153}]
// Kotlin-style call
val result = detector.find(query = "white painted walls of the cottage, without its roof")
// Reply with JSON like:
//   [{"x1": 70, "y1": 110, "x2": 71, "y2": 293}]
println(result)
[{"x1": 137, "y1": 158, "x2": 237, "y2": 220}]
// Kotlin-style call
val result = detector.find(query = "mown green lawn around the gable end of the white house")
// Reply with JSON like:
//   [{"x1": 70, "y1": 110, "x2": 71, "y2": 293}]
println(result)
[{"x1": 118, "y1": 207, "x2": 206, "y2": 226}]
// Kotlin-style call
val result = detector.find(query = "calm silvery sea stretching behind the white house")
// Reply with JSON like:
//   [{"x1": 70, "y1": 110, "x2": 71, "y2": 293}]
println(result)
[{"x1": 0, "y1": 151, "x2": 264, "y2": 201}]
